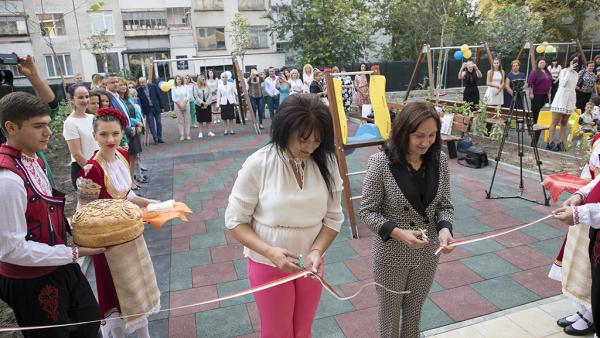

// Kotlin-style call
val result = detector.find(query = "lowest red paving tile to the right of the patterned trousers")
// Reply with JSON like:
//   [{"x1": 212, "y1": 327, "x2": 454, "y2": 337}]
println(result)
[{"x1": 430, "y1": 286, "x2": 499, "y2": 322}]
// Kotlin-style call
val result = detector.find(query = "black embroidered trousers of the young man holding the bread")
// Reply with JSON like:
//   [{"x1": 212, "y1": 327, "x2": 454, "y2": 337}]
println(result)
[{"x1": 0, "y1": 263, "x2": 100, "y2": 338}]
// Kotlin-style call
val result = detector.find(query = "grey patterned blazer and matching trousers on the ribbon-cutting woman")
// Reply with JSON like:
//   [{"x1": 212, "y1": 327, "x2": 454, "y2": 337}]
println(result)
[{"x1": 360, "y1": 152, "x2": 454, "y2": 338}]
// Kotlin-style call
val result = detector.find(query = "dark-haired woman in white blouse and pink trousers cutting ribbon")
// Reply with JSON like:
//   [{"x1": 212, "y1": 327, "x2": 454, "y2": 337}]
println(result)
[{"x1": 225, "y1": 94, "x2": 344, "y2": 337}]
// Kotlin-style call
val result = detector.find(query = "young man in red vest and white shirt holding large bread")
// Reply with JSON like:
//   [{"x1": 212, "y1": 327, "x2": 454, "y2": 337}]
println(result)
[{"x1": 0, "y1": 92, "x2": 104, "y2": 338}]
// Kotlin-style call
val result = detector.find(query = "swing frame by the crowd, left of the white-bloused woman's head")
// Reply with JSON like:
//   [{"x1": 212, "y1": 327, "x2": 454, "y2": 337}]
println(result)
[{"x1": 152, "y1": 53, "x2": 261, "y2": 135}]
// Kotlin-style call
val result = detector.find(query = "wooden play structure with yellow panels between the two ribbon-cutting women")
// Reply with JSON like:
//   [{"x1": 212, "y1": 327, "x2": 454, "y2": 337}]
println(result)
[{"x1": 325, "y1": 71, "x2": 392, "y2": 238}]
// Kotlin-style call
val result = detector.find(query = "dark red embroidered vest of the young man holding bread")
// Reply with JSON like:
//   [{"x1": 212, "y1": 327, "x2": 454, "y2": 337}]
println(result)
[{"x1": 0, "y1": 144, "x2": 70, "y2": 279}]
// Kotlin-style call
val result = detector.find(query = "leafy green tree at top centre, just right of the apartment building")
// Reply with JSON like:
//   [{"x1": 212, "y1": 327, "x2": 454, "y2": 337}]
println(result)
[{"x1": 267, "y1": 0, "x2": 374, "y2": 65}]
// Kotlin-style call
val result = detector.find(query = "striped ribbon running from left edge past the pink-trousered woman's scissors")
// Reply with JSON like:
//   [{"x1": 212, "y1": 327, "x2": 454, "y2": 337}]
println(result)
[{"x1": 0, "y1": 270, "x2": 410, "y2": 333}]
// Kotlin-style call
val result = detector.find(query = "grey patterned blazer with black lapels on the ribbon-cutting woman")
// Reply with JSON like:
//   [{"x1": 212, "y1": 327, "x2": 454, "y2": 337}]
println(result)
[{"x1": 360, "y1": 152, "x2": 454, "y2": 267}]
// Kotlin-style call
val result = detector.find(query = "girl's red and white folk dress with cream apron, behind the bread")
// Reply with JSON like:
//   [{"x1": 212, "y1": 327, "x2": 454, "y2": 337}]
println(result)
[{"x1": 77, "y1": 148, "x2": 160, "y2": 337}]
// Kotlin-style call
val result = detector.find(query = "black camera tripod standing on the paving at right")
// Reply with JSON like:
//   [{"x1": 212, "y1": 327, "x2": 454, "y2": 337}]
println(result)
[{"x1": 486, "y1": 80, "x2": 550, "y2": 206}]
